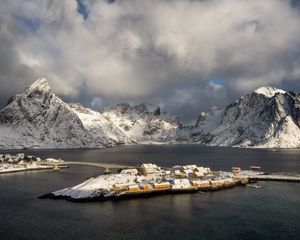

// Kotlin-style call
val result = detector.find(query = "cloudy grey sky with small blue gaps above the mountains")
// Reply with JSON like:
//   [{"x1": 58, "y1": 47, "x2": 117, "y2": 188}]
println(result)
[{"x1": 0, "y1": 0, "x2": 300, "y2": 122}]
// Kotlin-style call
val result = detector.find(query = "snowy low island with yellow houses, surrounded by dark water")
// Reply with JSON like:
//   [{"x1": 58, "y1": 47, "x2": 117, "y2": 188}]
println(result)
[{"x1": 39, "y1": 163, "x2": 270, "y2": 202}]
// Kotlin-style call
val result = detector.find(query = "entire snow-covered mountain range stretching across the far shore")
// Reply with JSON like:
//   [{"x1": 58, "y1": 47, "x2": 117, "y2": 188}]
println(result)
[{"x1": 0, "y1": 78, "x2": 300, "y2": 148}]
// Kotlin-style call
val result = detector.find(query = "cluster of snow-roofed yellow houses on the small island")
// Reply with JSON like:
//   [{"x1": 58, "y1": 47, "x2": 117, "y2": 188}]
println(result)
[{"x1": 111, "y1": 163, "x2": 245, "y2": 194}]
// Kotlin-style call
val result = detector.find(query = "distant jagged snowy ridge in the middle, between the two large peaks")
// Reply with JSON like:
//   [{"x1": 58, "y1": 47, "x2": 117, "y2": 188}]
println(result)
[{"x1": 102, "y1": 103, "x2": 181, "y2": 143}]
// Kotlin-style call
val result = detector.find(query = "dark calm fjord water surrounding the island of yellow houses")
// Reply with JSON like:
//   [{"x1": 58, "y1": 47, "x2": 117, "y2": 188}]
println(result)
[{"x1": 0, "y1": 145, "x2": 300, "y2": 240}]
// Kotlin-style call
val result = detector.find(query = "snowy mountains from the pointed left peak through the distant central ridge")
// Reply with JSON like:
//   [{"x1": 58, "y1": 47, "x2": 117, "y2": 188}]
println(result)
[{"x1": 0, "y1": 78, "x2": 180, "y2": 148}]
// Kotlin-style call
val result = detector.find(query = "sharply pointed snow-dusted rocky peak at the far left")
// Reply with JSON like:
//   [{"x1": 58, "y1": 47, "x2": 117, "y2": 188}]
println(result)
[{"x1": 0, "y1": 79, "x2": 127, "y2": 148}]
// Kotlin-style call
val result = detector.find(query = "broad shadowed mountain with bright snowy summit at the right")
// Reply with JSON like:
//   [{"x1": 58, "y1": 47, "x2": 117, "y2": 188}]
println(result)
[{"x1": 190, "y1": 87, "x2": 300, "y2": 148}]
